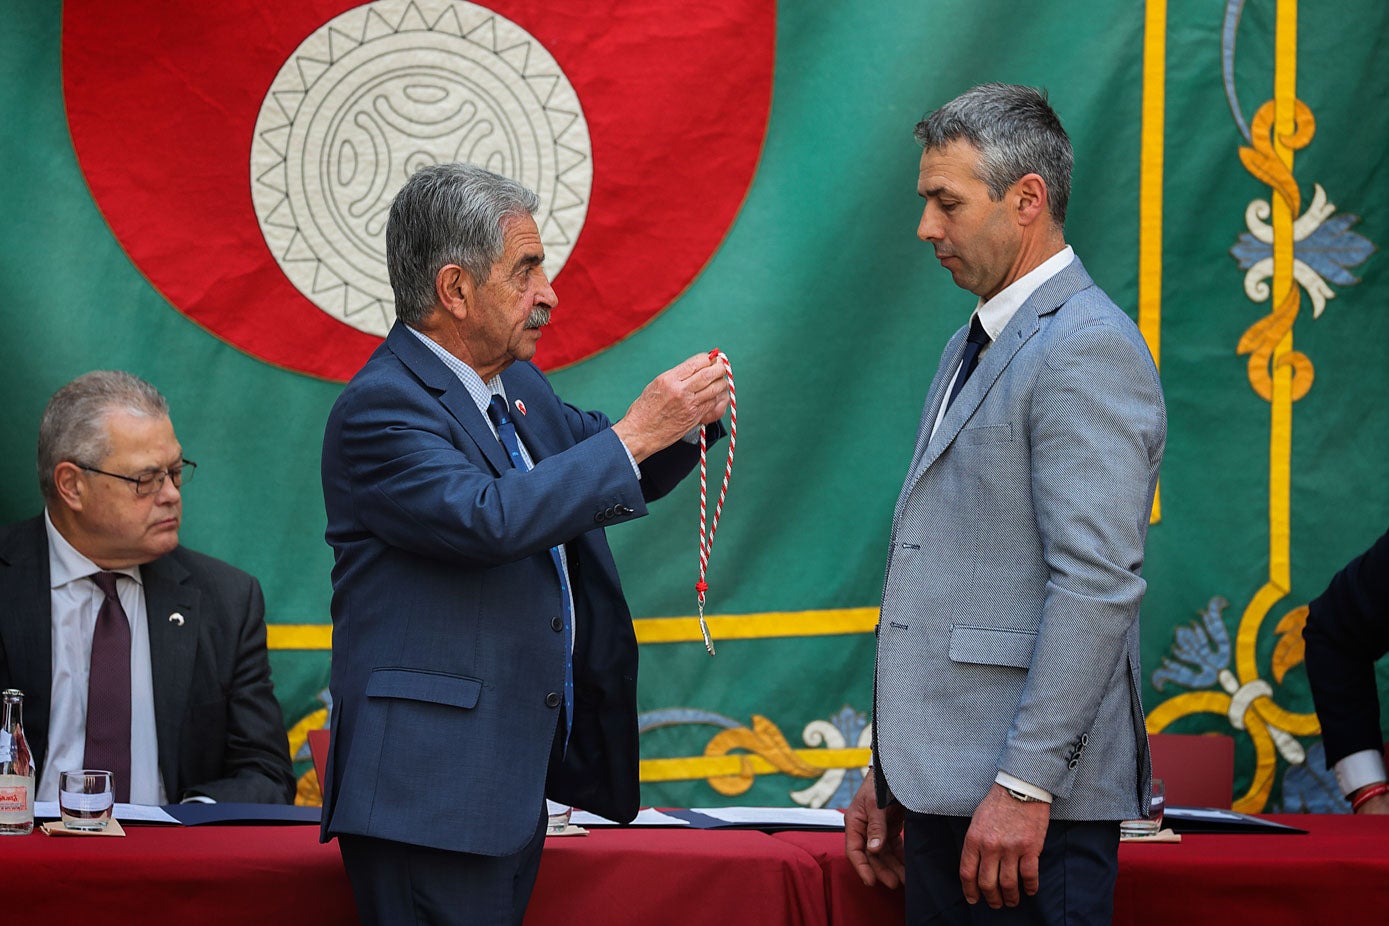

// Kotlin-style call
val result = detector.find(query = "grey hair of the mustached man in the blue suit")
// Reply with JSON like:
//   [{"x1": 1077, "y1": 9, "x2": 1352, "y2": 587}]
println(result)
[{"x1": 386, "y1": 164, "x2": 540, "y2": 328}]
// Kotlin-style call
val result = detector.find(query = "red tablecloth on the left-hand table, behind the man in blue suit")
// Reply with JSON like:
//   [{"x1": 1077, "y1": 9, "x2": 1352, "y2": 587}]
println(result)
[{"x1": 0, "y1": 826, "x2": 828, "y2": 926}]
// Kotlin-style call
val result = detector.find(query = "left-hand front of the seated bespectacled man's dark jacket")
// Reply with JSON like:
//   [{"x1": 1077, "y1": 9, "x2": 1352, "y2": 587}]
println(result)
[{"x1": 0, "y1": 515, "x2": 53, "y2": 764}]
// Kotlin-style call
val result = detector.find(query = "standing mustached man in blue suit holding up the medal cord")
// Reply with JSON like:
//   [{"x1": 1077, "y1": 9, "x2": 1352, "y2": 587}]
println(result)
[{"x1": 322, "y1": 164, "x2": 728, "y2": 923}]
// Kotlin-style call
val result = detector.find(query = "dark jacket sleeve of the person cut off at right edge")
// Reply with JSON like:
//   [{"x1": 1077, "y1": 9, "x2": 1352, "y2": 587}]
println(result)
[{"x1": 1303, "y1": 530, "x2": 1389, "y2": 768}]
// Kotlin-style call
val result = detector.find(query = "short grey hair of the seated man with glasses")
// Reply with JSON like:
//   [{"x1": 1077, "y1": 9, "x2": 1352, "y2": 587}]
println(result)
[{"x1": 39, "y1": 369, "x2": 169, "y2": 503}]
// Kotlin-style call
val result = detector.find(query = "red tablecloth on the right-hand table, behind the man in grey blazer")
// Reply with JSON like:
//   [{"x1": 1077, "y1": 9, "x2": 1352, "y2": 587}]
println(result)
[{"x1": 776, "y1": 815, "x2": 1389, "y2": 926}]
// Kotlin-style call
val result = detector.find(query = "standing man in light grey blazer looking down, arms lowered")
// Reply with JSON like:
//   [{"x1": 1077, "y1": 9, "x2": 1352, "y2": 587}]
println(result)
[{"x1": 846, "y1": 85, "x2": 1167, "y2": 926}]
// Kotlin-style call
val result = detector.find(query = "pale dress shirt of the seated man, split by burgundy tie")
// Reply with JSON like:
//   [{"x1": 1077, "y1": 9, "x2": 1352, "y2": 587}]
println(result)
[{"x1": 36, "y1": 510, "x2": 168, "y2": 804}]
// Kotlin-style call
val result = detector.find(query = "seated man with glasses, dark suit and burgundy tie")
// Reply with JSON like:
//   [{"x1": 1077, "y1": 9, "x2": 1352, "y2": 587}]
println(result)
[{"x1": 0, "y1": 371, "x2": 294, "y2": 804}]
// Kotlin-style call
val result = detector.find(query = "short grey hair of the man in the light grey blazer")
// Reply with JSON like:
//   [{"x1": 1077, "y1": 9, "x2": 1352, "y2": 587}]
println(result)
[{"x1": 913, "y1": 83, "x2": 1075, "y2": 228}]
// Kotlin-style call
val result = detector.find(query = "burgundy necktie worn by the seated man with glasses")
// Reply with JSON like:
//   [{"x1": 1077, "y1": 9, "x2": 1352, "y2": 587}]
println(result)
[{"x1": 82, "y1": 572, "x2": 131, "y2": 802}]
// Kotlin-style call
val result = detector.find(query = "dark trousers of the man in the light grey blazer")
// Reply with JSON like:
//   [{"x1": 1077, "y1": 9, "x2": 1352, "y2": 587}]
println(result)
[{"x1": 904, "y1": 814, "x2": 1120, "y2": 926}]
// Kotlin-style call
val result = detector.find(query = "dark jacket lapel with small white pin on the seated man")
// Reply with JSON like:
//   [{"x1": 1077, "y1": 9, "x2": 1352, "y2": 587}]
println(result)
[{"x1": 140, "y1": 557, "x2": 204, "y2": 802}]
